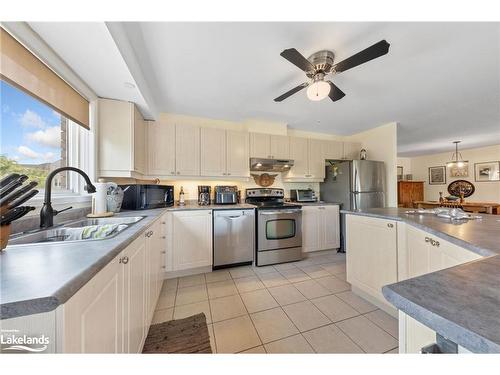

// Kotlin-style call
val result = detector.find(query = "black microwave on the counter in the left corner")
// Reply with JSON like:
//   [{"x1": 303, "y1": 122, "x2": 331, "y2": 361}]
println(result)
[{"x1": 120, "y1": 185, "x2": 174, "y2": 210}]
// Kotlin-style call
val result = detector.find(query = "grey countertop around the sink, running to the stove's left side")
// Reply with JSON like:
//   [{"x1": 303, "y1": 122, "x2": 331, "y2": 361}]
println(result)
[{"x1": 0, "y1": 202, "x2": 255, "y2": 319}]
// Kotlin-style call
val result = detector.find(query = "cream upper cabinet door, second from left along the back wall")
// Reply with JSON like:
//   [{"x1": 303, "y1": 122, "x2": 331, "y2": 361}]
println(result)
[{"x1": 175, "y1": 124, "x2": 200, "y2": 176}]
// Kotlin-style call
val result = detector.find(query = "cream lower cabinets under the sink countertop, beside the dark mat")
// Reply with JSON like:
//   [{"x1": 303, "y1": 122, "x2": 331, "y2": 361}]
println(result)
[{"x1": 56, "y1": 222, "x2": 165, "y2": 353}]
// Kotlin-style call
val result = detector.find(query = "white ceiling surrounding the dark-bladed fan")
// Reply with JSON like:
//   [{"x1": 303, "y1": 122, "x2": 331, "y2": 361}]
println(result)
[{"x1": 30, "y1": 22, "x2": 500, "y2": 156}]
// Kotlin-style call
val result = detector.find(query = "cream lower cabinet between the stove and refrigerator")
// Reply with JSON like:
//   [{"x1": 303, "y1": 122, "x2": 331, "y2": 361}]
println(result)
[{"x1": 302, "y1": 205, "x2": 340, "y2": 253}]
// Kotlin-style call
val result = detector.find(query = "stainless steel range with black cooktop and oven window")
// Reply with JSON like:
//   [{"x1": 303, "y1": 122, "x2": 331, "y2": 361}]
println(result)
[{"x1": 245, "y1": 188, "x2": 302, "y2": 266}]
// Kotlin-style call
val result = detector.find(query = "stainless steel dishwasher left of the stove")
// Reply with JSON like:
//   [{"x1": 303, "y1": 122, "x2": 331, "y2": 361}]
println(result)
[{"x1": 213, "y1": 209, "x2": 255, "y2": 269}]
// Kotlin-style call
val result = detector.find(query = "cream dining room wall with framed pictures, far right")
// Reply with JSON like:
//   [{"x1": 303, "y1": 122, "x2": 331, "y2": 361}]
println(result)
[{"x1": 411, "y1": 145, "x2": 500, "y2": 202}]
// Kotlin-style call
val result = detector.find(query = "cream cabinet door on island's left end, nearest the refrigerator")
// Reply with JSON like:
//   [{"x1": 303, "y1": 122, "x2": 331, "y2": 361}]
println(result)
[{"x1": 346, "y1": 215, "x2": 398, "y2": 303}]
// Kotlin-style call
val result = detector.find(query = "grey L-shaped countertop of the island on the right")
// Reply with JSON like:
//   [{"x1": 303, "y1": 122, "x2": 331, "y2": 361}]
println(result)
[{"x1": 342, "y1": 208, "x2": 500, "y2": 353}]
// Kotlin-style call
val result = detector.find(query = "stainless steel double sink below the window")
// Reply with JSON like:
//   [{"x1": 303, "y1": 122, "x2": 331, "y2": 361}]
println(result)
[{"x1": 9, "y1": 216, "x2": 145, "y2": 246}]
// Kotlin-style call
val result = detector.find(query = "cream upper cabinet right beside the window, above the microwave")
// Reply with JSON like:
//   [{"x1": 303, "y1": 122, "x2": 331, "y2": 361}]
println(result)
[{"x1": 97, "y1": 99, "x2": 146, "y2": 177}]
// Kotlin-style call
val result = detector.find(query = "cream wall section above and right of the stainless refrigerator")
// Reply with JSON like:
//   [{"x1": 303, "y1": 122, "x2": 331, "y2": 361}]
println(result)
[{"x1": 346, "y1": 122, "x2": 398, "y2": 207}]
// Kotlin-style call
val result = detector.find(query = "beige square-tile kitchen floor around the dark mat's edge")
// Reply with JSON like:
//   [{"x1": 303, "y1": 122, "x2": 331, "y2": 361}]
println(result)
[{"x1": 153, "y1": 251, "x2": 398, "y2": 353}]
